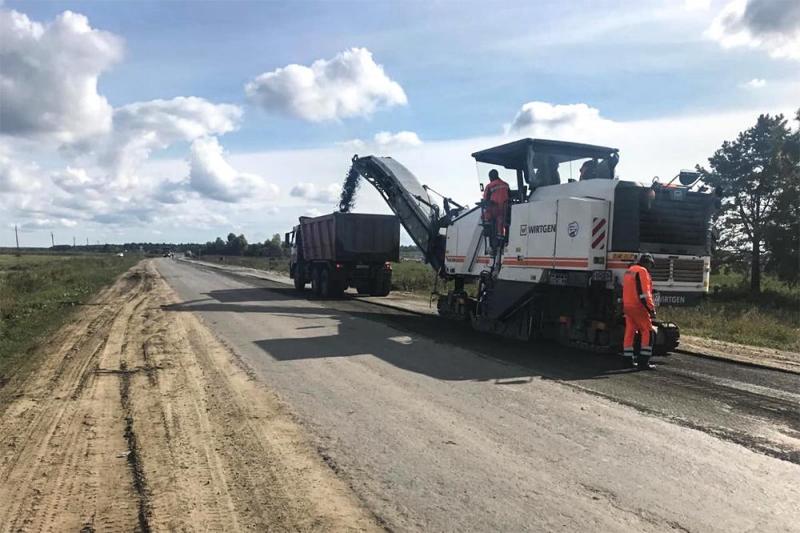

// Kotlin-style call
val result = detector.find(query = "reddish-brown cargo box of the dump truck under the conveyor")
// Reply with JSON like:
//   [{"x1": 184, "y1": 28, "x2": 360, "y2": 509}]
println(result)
[{"x1": 300, "y1": 213, "x2": 400, "y2": 263}]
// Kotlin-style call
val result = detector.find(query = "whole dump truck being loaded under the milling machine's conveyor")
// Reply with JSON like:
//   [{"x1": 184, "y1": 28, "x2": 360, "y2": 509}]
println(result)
[{"x1": 286, "y1": 213, "x2": 400, "y2": 298}]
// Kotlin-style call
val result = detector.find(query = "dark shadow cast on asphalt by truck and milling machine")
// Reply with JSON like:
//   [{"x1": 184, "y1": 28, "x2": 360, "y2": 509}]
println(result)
[{"x1": 165, "y1": 287, "x2": 644, "y2": 385}]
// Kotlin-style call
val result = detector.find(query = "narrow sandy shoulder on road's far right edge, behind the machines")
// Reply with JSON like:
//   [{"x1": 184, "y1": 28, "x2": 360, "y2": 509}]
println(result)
[{"x1": 186, "y1": 261, "x2": 800, "y2": 374}]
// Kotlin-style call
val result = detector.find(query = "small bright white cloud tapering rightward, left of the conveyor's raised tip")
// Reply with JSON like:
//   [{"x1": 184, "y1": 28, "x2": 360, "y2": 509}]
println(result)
[{"x1": 188, "y1": 137, "x2": 279, "y2": 203}]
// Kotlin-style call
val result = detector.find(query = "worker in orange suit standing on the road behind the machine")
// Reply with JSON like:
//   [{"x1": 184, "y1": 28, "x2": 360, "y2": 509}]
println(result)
[{"x1": 622, "y1": 254, "x2": 656, "y2": 370}]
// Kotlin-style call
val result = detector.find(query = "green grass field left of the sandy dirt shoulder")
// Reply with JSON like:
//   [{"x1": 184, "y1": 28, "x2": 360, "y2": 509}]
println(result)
[{"x1": 0, "y1": 255, "x2": 139, "y2": 385}]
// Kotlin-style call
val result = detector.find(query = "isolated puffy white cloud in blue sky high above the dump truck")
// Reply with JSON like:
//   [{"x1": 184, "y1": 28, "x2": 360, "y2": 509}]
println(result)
[{"x1": 245, "y1": 48, "x2": 408, "y2": 122}]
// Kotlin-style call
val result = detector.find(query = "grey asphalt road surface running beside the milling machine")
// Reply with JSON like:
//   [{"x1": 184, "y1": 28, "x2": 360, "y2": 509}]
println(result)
[{"x1": 158, "y1": 260, "x2": 800, "y2": 531}]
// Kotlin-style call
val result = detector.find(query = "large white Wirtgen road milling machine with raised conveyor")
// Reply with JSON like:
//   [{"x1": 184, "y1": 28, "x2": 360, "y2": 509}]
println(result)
[{"x1": 343, "y1": 139, "x2": 719, "y2": 354}]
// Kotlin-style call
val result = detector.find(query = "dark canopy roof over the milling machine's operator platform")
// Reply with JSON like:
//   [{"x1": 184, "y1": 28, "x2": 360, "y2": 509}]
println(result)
[{"x1": 472, "y1": 139, "x2": 619, "y2": 187}]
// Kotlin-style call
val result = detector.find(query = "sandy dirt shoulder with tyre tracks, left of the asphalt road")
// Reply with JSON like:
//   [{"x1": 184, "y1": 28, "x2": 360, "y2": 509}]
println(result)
[{"x1": 0, "y1": 262, "x2": 379, "y2": 531}]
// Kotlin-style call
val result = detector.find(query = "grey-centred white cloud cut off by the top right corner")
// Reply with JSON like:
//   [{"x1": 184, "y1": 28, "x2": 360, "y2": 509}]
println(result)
[{"x1": 705, "y1": 0, "x2": 800, "y2": 60}]
